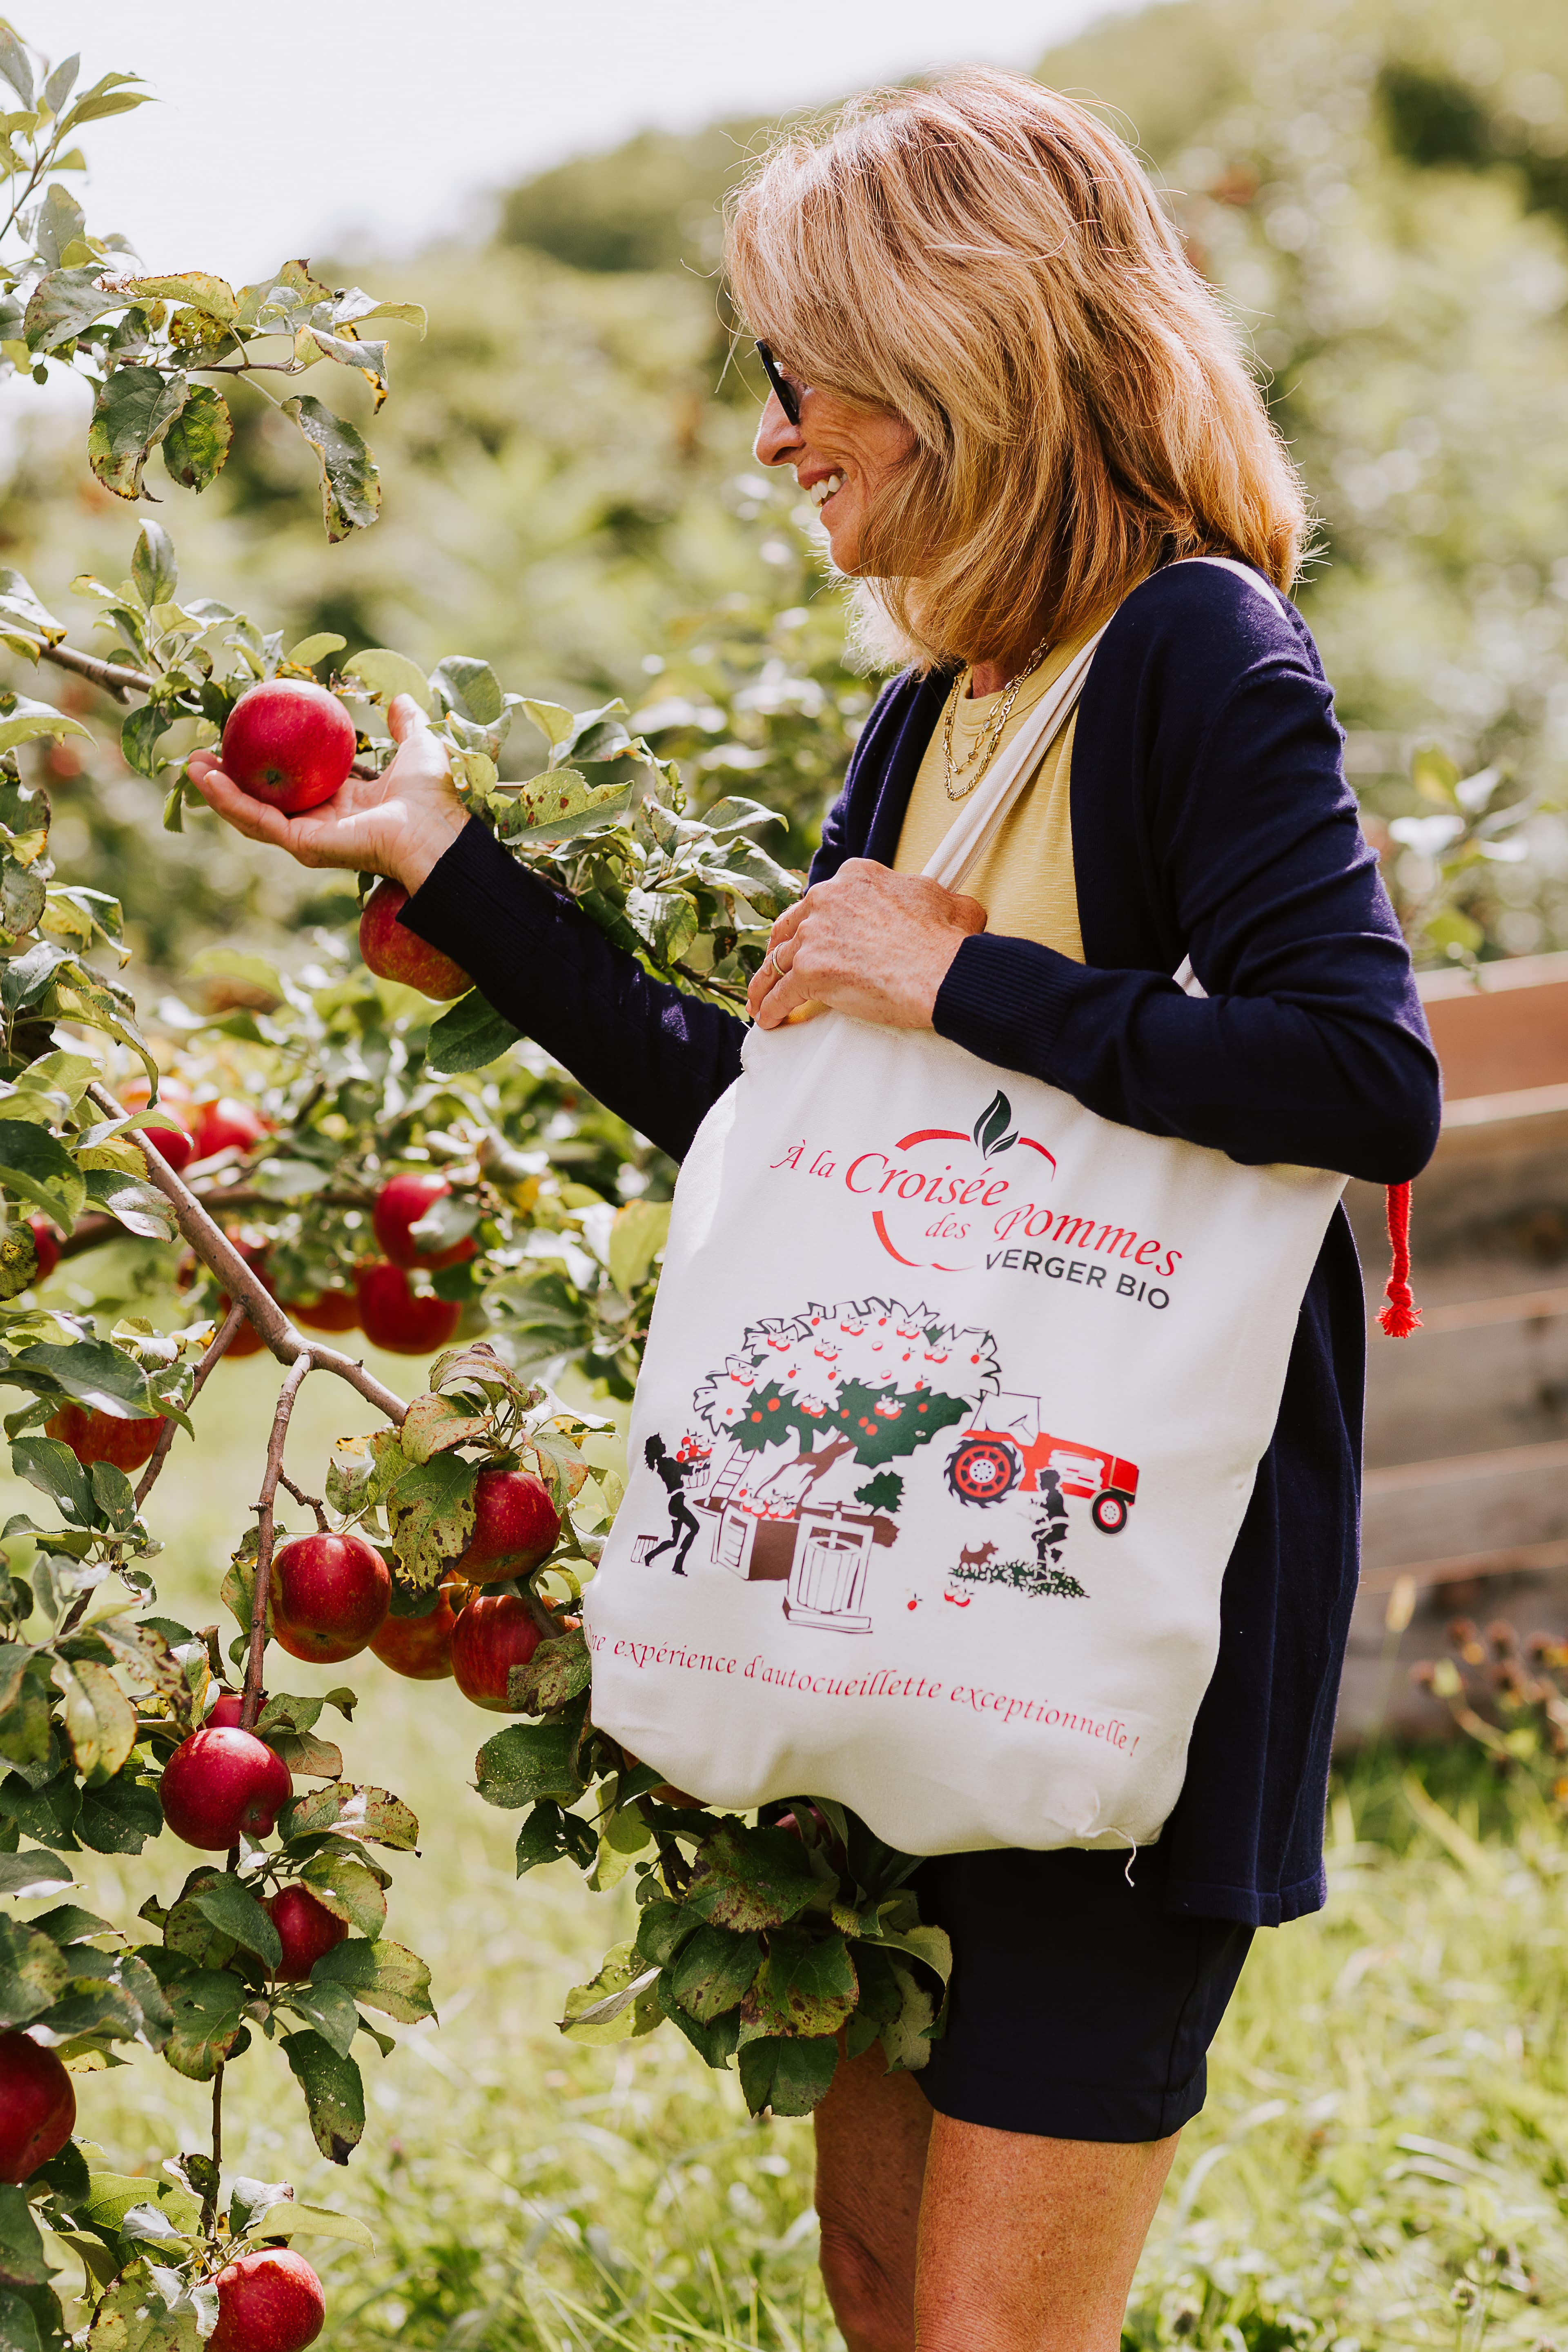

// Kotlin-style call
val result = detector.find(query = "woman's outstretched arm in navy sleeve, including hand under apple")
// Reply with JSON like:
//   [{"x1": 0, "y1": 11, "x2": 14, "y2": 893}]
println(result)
[{"x1": 190, "y1": 694, "x2": 745, "y2": 1160}]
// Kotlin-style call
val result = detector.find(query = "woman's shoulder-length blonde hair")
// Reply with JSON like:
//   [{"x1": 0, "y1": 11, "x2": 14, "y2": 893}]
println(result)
[{"x1": 726, "y1": 66, "x2": 1307, "y2": 668}]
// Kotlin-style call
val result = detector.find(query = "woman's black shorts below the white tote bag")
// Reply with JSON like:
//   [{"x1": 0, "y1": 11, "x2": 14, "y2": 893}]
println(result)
[{"x1": 912, "y1": 1846, "x2": 1253, "y2": 2140}]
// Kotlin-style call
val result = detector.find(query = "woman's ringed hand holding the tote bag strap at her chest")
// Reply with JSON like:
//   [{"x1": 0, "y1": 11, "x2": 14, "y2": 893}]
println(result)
[{"x1": 745, "y1": 858, "x2": 985, "y2": 1028}]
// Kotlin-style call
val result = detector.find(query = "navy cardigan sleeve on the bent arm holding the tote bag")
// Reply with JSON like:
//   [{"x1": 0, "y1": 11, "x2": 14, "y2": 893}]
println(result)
[{"x1": 933, "y1": 564, "x2": 1441, "y2": 1183}]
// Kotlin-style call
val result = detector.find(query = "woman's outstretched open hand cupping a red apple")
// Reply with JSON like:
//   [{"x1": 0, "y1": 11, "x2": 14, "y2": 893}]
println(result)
[{"x1": 186, "y1": 694, "x2": 468, "y2": 896}]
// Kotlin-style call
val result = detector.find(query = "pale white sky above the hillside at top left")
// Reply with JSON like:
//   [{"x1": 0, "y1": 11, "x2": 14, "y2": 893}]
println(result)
[{"x1": 52, "y1": 0, "x2": 1152, "y2": 280}]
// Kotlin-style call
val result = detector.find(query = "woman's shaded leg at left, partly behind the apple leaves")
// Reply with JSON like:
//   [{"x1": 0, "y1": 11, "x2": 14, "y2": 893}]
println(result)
[{"x1": 816, "y1": 2044, "x2": 931, "y2": 2352}]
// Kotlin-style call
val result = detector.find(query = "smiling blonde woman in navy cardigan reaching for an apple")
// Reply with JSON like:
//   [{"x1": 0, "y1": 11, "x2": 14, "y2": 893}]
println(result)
[{"x1": 193, "y1": 71, "x2": 1439, "y2": 2352}]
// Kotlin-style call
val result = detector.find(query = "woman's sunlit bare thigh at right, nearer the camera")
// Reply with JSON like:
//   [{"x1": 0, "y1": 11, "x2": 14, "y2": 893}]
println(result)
[{"x1": 907, "y1": 2114, "x2": 1180, "y2": 2352}]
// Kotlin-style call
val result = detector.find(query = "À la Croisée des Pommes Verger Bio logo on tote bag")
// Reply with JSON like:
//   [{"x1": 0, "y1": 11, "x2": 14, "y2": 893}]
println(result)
[{"x1": 771, "y1": 1089, "x2": 1183, "y2": 1308}]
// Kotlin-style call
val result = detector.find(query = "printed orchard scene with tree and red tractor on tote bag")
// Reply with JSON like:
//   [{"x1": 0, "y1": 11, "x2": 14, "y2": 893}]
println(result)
[{"x1": 633, "y1": 1298, "x2": 1138, "y2": 1632}]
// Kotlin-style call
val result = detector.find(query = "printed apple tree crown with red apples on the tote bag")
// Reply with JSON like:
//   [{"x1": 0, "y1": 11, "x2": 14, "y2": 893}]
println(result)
[{"x1": 693, "y1": 1298, "x2": 999, "y2": 1510}]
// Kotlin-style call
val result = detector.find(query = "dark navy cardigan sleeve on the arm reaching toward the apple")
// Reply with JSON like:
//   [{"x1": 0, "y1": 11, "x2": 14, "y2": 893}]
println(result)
[{"x1": 397, "y1": 816, "x2": 745, "y2": 1160}]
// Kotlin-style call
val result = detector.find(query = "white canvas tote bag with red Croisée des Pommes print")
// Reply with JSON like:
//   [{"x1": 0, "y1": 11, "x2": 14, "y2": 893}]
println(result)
[{"x1": 586, "y1": 602, "x2": 1345, "y2": 1853}]
